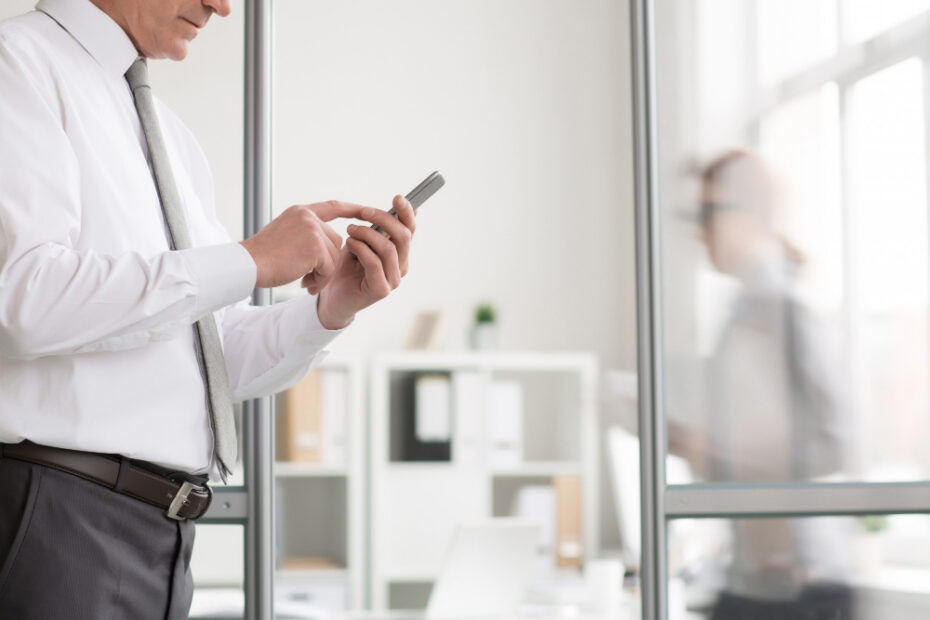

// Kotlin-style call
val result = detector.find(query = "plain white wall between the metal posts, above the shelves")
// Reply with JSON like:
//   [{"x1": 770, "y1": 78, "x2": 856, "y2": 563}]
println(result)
[{"x1": 264, "y1": 0, "x2": 635, "y2": 369}]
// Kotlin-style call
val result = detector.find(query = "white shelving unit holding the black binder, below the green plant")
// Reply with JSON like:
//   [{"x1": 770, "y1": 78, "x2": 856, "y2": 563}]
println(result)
[{"x1": 369, "y1": 352, "x2": 599, "y2": 609}]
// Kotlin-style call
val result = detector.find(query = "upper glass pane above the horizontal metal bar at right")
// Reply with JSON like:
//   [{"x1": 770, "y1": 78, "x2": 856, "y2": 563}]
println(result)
[{"x1": 656, "y1": 0, "x2": 930, "y2": 482}]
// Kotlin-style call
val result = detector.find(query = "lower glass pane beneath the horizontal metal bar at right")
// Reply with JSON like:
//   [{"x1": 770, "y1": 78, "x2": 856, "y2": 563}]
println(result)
[{"x1": 668, "y1": 515, "x2": 930, "y2": 620}]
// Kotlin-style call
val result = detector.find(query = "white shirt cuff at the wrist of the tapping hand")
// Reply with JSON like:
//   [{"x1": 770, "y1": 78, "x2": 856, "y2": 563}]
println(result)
[{"x1": 180, "y1": 243, "x2": 258, "y2": 318}]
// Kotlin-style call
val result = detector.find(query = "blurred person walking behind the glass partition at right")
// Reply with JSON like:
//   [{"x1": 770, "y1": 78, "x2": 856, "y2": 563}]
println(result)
[{"x1": 685, "y1": 150, "x2": 856, "y2": 620}]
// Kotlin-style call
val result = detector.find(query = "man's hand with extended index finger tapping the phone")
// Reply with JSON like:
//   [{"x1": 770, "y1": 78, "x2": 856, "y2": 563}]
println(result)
[{"x1": 241, "y1": 200, "x2": 376, "y2": 293}]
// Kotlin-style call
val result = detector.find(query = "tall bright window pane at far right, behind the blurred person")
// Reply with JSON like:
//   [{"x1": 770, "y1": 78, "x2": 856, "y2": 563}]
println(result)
[{"x1": 849, "y1": 59, "x2": 930, "y2": 480}]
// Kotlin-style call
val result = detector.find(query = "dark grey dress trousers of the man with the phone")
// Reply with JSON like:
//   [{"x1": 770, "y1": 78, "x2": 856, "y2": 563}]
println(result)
[{"x1": 0, "y1": 457, "x2": 194, "y2": 620}]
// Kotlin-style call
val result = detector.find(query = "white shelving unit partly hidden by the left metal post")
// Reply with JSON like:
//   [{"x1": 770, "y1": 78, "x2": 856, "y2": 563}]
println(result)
[{"x1": 274, "y1": 355, "x2": 367, "y2": 611}]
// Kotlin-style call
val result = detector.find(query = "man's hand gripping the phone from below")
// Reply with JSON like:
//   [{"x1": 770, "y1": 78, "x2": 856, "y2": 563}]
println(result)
[{"x1": 316, "y1": 196, "x2": 416, "y2": 329}]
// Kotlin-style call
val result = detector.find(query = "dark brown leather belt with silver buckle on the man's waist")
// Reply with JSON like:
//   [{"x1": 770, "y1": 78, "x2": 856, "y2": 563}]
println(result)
[{"x1": 0, "y1": 441, "x2": 213, "y2": 521}]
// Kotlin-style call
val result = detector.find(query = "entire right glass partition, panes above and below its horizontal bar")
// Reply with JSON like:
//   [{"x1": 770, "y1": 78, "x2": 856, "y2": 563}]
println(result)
[{"x1": 635, "y1": 0, "x2": 930, "y2": 620}]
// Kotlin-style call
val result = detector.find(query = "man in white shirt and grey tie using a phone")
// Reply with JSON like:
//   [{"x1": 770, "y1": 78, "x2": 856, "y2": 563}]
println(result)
[{"x1": 0, "y1": 0, "x2": 415, "y2": 620}]
